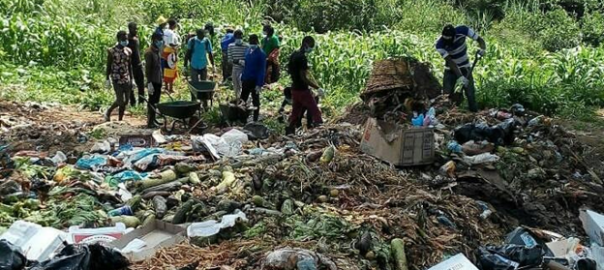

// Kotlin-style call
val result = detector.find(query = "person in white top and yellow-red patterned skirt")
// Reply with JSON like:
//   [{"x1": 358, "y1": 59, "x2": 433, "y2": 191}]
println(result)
[{"x1": 161, "y1": 19, "x2": 180, "y2": 93}]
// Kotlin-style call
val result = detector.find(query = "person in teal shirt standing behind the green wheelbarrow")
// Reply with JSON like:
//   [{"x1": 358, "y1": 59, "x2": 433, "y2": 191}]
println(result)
[{"x1": 185, "y1": 29, "x2": 216, "y2": 82}]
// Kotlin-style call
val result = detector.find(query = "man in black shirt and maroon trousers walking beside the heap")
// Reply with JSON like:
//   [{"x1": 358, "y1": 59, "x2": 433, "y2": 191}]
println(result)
[{"x1": 285, "y1": 36, "x2": 324, "y2": 134}]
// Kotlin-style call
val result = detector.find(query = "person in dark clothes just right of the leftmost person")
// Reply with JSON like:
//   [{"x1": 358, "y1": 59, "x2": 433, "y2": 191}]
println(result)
[{"x1": 128, "y1": 22, "x2": 145, "y2": 106}]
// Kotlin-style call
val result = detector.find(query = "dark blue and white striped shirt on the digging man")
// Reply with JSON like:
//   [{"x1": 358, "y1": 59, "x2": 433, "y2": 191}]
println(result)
[{"x1": 435, "y1": 25, "x2": 478, "y2": 68}]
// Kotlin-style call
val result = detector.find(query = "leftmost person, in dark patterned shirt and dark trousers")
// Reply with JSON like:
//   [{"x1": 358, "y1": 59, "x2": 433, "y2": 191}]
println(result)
[{"x1": 105, "y1": 31, "x2": 133, "y2": 122}]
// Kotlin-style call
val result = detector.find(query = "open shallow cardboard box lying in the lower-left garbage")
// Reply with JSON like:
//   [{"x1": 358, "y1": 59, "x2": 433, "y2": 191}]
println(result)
[{"x1": 110, "y1": 220, "x2": 187, "y2": 262}]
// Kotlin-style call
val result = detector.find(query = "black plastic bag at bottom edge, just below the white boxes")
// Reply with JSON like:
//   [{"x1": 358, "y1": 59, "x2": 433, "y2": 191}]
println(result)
[{"x1": 28, "y1": 243, "x2": 130, "y2": 270}]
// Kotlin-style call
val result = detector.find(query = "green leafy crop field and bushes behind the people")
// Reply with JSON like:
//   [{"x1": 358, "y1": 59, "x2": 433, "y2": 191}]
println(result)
[{"x1": 0, "y1": 0, "x2": 604, "y2": 121}]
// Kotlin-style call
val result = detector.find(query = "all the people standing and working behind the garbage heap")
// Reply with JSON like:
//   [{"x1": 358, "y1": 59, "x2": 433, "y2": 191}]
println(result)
[{"x1": 105, "y1": 17, "x2": 486, "y2": 131}]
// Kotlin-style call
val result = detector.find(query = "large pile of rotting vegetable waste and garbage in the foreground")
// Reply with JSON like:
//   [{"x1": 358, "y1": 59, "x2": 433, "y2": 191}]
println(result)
[{"x1": 0, "y1": 70, "x2": 604, "y2": 270}]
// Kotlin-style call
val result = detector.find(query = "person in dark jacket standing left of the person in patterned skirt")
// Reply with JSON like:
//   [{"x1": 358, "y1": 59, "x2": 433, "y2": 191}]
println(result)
[{"x1": 145, "y1": 33, "x2": 164, "y2": 128}]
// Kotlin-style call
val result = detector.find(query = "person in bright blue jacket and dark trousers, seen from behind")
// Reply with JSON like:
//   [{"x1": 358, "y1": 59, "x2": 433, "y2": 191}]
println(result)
[{"x1": 241, "y1": 35, "x2": 266, "y2": 122}]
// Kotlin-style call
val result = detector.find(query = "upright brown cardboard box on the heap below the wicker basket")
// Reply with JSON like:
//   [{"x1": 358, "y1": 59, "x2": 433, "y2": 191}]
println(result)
[{"x1": 361, "y1": 118, "x2": 434, "y2": 166}]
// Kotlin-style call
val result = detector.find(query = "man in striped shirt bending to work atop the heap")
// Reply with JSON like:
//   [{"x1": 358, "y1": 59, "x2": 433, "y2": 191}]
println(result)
[{"x1": 436, "y1": 24, "x2": 486, "y2": 112}]
